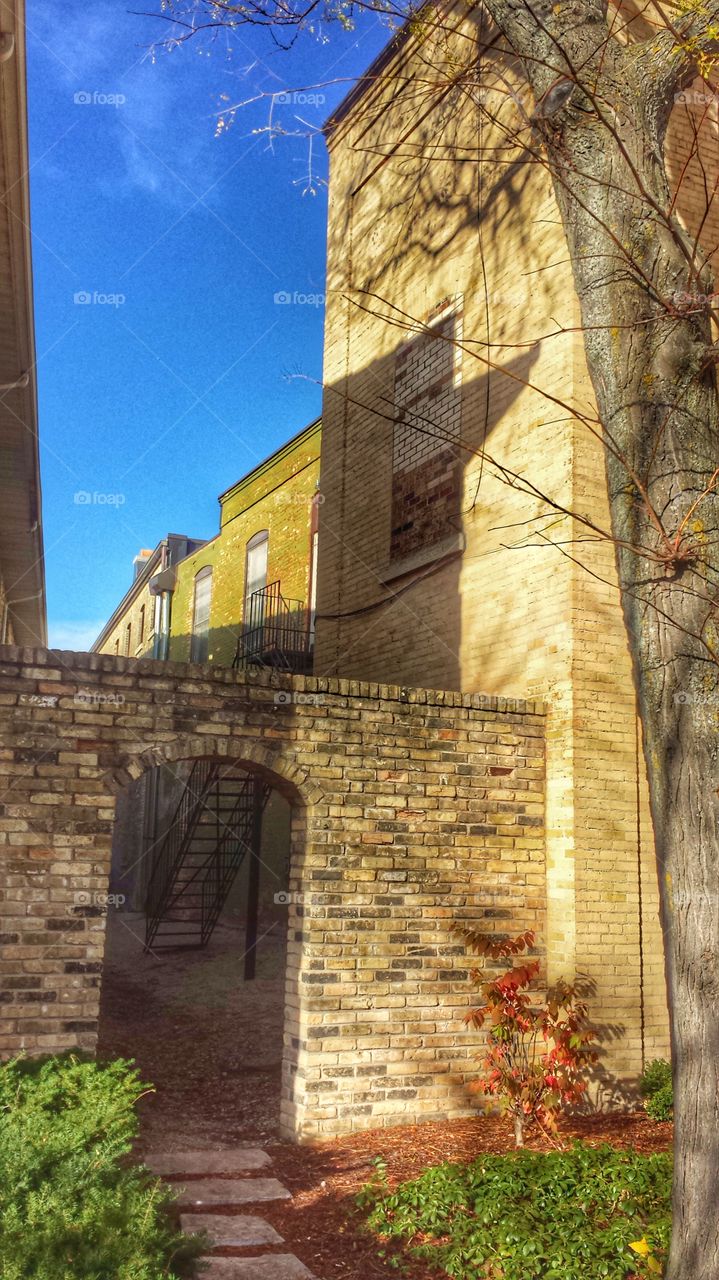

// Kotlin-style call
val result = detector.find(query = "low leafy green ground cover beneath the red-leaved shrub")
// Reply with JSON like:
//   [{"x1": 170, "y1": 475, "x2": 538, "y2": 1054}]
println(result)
[{"x1": 360, "y1": 1142, "x2": 672, "y2": 1280}]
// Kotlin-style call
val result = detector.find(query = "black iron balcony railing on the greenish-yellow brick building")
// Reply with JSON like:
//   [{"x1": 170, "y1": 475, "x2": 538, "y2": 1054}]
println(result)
[{"x1": 233, "y1": 581, "x2": 315, "y2": 675}]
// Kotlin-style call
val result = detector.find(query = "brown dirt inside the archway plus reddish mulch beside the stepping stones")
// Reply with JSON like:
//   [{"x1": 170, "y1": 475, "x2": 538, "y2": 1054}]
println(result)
[{"x1": 100, "y1": 914, "x2": 672, "y2": 1280}]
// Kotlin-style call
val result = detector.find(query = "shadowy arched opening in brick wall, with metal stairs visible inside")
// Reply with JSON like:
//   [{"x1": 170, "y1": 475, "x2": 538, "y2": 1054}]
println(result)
[{"x1": 99, "y1": 751, "x2": 306, "y2": 1148}]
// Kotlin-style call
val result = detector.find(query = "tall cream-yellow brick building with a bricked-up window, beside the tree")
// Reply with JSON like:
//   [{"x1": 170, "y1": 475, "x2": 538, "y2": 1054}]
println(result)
[{"x1": 315, "y1": 9, "x2": 719, "y2": 1080}]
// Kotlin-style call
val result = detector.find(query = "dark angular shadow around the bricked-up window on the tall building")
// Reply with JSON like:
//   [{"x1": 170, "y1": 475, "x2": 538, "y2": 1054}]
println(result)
[{"x1": 315, "y1": 340, "x2": 537, "y2": 695}]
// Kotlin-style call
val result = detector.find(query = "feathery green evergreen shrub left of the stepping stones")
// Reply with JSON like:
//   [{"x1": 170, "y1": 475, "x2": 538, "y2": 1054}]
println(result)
[{"x1": 0, "y1": 1055, "x2": 202, "y2": 1280}]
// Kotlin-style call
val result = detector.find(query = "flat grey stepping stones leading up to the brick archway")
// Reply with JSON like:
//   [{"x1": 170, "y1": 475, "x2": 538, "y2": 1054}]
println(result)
[{"x1": 145, "y1": 1147, "x2": 316, "y2": 1280}]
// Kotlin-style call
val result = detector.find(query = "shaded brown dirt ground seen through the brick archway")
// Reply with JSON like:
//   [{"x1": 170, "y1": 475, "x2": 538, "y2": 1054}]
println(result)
[{"x1": 99, "y1": 911, "x2": 285, "y2": 1151}]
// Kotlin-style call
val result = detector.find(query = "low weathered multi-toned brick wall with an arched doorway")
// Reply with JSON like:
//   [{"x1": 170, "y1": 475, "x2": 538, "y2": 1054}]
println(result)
[{"x1": 0, "y1": 648, "x2": 546, "y2": 1138}]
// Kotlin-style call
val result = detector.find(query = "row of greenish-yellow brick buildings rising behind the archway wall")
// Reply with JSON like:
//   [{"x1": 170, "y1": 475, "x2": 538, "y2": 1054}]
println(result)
[{"x1": 92, "y1": 420, "x2": 322, "y2": 669}]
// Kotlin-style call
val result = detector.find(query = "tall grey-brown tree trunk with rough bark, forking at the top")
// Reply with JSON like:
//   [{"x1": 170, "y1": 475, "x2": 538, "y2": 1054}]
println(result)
[{"x1": 470, "y1": 0, "x2": 719, "y2": 1280}]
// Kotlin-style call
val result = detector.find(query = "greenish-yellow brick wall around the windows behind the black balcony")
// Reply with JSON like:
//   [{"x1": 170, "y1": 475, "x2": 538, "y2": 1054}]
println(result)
[{"x1": 170, "y1": 422, "x2": 321, "y2": 666}]
